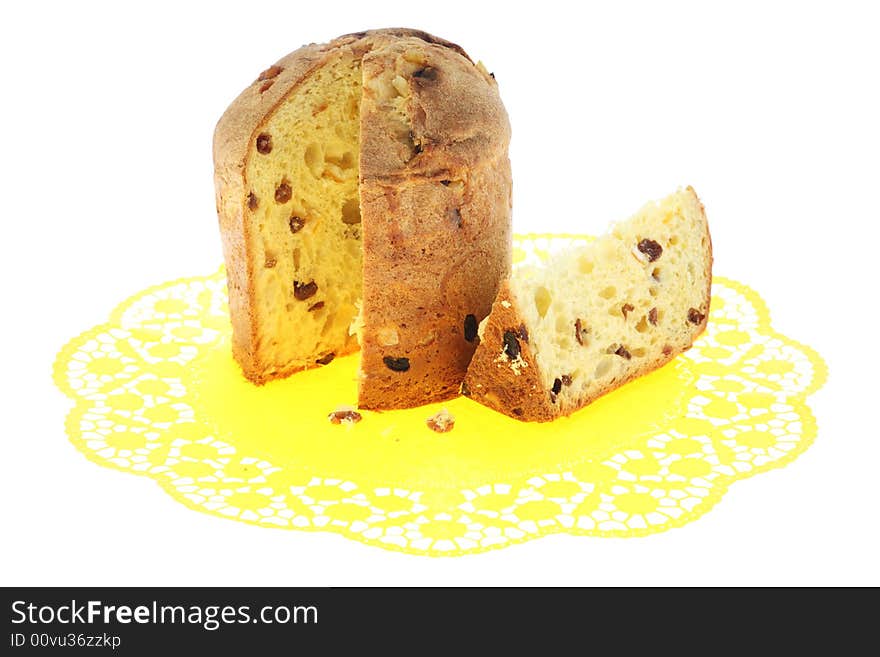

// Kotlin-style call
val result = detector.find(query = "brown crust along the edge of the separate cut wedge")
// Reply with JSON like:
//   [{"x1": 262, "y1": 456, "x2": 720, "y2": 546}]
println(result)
[{"x1": 462, "y1": 187, "x2": 712, "y2": 422}]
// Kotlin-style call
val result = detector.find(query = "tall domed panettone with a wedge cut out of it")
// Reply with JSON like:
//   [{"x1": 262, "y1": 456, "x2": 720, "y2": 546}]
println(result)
[{"x1": 214, "y1": 28, "x2": 511, "y2": 409}]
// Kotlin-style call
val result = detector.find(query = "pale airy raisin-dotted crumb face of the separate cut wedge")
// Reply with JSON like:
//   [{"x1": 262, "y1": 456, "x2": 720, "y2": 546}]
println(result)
[{"x1": 498, "y1": 189, "x2": 710, "y2": 399}]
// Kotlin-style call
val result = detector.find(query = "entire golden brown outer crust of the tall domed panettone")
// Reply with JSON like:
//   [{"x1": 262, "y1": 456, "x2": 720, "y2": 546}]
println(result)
[{"x1": 214, "y1": 28, "x2": 511, "y2": 394}]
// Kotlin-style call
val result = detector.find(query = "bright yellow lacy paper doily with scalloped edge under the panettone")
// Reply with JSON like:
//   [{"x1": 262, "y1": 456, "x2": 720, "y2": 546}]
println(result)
[{"x1": 54, "y1": 235, "x2": 825, "y2": 556}]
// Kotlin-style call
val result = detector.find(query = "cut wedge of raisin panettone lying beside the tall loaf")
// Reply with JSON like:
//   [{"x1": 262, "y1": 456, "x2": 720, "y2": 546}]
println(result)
[{"x1": 462, "y1": 187, "x2": 712, "y2": 422}]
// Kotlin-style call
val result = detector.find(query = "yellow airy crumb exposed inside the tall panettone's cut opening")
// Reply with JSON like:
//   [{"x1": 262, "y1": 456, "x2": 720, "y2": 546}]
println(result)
[{"x1": 245, "y1": 54, "x2": 363, "y2": 376}]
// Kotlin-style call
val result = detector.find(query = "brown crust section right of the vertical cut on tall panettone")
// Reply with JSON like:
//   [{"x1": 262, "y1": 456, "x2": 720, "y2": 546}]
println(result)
[{"x1": 358, "y1": 37, "x2": 511, "y2": 409}]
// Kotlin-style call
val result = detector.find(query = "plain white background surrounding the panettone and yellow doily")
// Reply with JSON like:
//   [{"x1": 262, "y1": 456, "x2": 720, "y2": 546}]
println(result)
[{"x1": 0, "y1": 1, "x2": 880, "y2": 585}]
